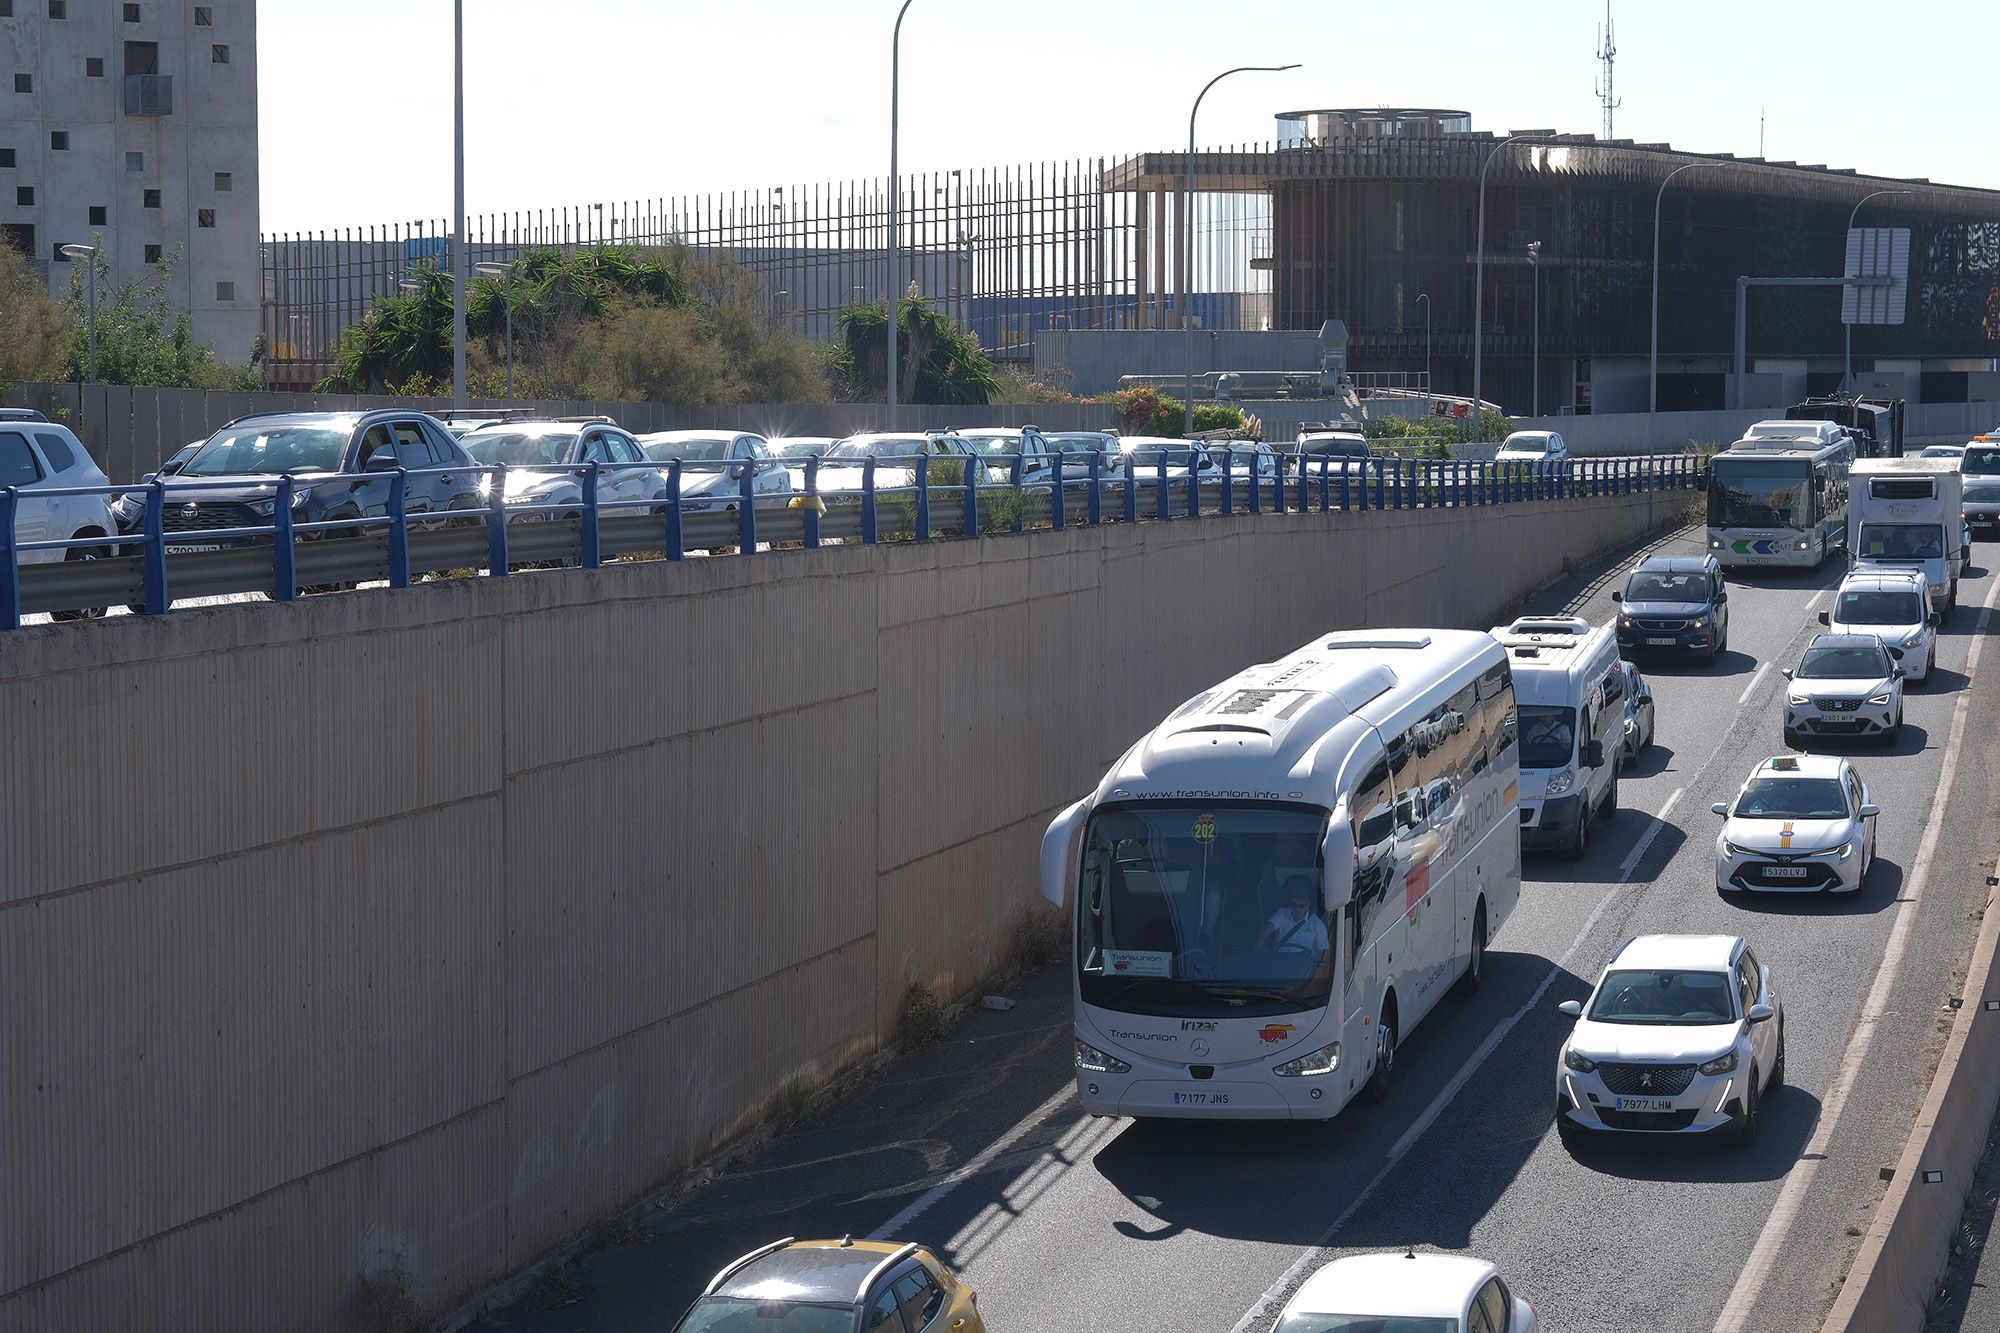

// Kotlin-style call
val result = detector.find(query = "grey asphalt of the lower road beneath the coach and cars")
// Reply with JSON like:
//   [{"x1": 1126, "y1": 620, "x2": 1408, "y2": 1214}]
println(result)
[{"x1": 480, "y1": 534, "x2": 2000, "y2": 1333}]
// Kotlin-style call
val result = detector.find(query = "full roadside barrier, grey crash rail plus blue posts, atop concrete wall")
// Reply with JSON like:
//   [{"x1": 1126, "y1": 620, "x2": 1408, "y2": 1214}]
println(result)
[{"x1": 0, "y1": 448, "x2": 1706, "y2": 630}]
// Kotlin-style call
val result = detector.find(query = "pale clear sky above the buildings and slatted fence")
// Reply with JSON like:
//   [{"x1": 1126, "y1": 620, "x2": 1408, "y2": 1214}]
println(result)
[{"x1": 258, "y1": 0, "x2": 2000, "y2": 232}]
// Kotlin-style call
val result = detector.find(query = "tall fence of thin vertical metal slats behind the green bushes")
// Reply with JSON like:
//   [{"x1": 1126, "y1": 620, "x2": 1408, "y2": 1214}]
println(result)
[{"x1": 262, "y1": 156, "x2": 1270, "y2": 388}]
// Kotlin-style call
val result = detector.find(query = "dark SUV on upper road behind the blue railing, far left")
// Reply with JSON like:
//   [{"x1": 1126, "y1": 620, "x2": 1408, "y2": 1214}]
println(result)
[{"x1": 120, "y1": 410, "x2": 482, "y2": 550}]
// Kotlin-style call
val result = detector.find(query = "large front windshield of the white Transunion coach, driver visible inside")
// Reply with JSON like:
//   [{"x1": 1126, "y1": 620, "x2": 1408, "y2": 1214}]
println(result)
[{"x1": 1076, "y1": 801, "x2": 1334, "y2": 1017}]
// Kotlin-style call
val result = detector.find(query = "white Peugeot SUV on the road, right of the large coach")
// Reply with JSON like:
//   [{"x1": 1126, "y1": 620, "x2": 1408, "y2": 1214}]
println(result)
[{"x1": 1556, "y1": 935, "x2": 1784, "y2": 1143}]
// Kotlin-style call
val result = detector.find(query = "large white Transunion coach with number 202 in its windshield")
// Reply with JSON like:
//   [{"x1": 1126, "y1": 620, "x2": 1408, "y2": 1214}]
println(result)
[{"x1": 1042, "y1": 630, "x2": 1520, "y2": 1119}]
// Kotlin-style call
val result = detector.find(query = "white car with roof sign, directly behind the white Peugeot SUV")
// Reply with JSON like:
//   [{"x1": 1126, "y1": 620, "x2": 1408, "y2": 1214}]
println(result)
[{"x1": 1710, "y1": 755, "x2": 1882, "y2": 893}]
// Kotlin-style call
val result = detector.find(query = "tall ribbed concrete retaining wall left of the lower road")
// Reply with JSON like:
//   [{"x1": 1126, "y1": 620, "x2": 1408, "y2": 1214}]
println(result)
[{"x1": 0, "y1": 492, "x2": 1688, "y2": 1331}]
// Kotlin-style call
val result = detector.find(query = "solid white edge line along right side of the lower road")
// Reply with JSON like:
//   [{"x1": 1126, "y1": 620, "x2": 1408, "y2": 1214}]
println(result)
[{"x1": 1716, "y1": 578, "x2": 2000, "y2": 1333}]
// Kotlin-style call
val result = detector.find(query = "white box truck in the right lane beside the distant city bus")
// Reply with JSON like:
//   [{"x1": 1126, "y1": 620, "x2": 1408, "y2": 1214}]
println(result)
[{"x1": 1848, "y1": 458, "x2": 1970, "y2": 614}]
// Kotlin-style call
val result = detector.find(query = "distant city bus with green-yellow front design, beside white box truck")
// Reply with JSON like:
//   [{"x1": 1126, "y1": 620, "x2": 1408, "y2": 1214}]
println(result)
[{"x1": 1708, "y1": 420, "x2": 1854, "y2": 568}]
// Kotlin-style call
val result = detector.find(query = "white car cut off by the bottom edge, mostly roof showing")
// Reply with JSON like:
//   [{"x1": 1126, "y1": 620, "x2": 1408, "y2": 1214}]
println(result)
[{"x1": 1272, "y1": 1251, "x2": 1534, "y2": 1333}]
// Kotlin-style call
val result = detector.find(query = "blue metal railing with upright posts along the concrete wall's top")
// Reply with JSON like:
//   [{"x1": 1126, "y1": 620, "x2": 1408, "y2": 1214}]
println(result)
[{"x1": 0, "y1": 448, "x2": 1706, "y2": 628}]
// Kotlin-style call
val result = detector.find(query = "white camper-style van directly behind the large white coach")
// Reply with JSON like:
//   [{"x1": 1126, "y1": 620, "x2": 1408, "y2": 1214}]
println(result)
[{"x1": 1492, "y1": 616, "x2": 1626, "y2": 859}]
